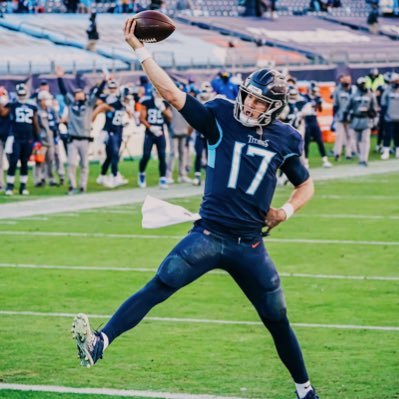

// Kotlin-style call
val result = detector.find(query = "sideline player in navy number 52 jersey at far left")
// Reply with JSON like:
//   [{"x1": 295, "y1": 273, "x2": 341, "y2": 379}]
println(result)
[{"x1": 0, "y1": 83, "x2": 40, "y2": 195}]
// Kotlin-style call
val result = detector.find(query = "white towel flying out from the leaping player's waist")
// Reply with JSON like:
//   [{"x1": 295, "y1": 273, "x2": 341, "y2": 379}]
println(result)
[{"x1": 141, "y1": 195, "x2": 201, "y2": 229}]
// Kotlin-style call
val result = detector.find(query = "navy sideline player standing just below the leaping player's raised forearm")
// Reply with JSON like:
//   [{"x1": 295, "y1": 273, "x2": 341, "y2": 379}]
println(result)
[{"x1": 138, "y1": 90, "x2": 172, "y2": 189}]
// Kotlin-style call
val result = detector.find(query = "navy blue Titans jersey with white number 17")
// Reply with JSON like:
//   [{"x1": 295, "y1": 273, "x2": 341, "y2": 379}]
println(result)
[{"x1": 181, "y1": 98, "x2": 308, "y2": 234}]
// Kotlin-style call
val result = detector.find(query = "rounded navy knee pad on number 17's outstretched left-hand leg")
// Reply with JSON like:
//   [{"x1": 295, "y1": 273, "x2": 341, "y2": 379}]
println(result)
[{"x1": 157, "y1": 253, "x2": 192, "y2": 288}]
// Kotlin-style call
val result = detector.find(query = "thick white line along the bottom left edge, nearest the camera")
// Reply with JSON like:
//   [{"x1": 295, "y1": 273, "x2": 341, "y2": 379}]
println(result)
[{"x1": 0, "y1": 384, "x2": 247, "y2": 399}]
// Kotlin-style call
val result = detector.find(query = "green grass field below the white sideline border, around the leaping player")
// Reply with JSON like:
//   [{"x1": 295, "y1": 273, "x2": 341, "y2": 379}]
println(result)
[{"x1": 0, "y1": 170, "x2": 399, "y2": 399}]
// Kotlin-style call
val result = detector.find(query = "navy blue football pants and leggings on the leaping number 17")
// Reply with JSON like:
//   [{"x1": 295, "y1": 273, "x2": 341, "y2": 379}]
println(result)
[{"x1": 102, "y1": 226, "x2": 309, "y2": 383}]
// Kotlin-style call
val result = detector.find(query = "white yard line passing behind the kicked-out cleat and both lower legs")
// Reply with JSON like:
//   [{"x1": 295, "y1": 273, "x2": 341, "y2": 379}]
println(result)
[{"x1": 0, "y1": 310, "x2": 399, "y2": 332}]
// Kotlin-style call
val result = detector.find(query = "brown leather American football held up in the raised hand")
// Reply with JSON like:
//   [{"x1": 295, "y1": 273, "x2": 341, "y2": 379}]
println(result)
[{"x1": 135, "y1": 10, "x2": 176, "y2": 43}]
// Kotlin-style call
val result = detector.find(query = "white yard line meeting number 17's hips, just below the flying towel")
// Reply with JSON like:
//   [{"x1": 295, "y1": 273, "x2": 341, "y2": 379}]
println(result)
[{"x1": 0, "y1": 230, "x2": 399, "y2": 247}]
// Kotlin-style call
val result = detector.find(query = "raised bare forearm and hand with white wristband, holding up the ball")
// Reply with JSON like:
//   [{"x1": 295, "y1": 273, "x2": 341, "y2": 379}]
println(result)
[{"x1": 124, "y1": 17, "x2": 186, "y2": 111}]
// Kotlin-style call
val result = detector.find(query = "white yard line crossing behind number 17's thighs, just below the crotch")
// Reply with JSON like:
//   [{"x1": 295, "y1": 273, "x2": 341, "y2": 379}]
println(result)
[{"x1": 0, "y1": 263, "x2": 399, "y2": 281}]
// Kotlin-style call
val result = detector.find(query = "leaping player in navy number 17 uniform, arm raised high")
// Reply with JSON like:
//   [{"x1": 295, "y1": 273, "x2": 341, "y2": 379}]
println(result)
[{"x1": 72, "y1": 18, "x2": 318, "y2": 399}]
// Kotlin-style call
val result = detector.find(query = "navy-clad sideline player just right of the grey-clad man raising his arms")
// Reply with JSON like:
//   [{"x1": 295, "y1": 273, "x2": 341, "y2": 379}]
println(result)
[{"x1": 93, "y1": 79, "x2": 128, "y2": 188}]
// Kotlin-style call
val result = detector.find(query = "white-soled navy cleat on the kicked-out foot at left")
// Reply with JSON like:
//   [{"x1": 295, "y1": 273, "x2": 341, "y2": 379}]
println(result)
[{"x1": 71, "y1": 313, "x2": 104, "y2": 368}]
